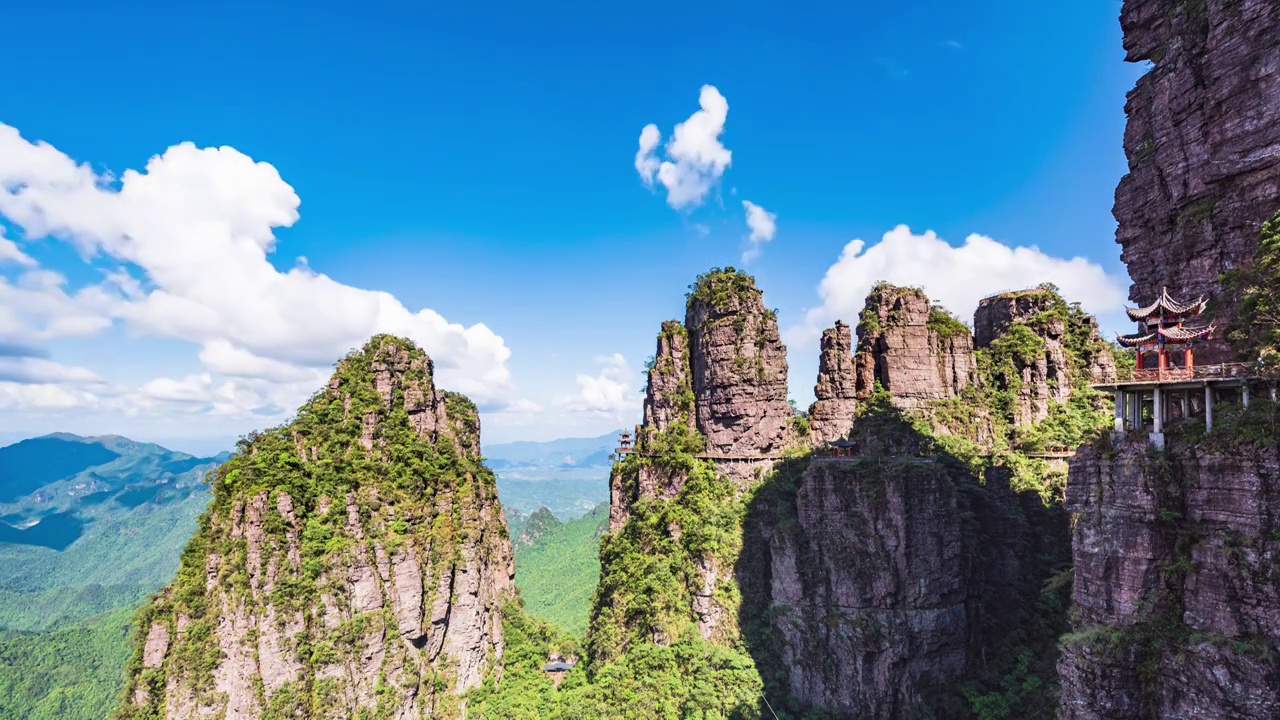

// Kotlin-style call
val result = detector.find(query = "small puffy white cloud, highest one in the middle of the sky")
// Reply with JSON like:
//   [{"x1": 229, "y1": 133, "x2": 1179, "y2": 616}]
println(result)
[{"x1": 635, "y1": 85, "x2": 732, "y2": 210}]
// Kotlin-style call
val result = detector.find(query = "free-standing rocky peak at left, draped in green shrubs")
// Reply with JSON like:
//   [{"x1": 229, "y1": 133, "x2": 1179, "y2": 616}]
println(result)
[{"x1": 118, "y1": 336, "x2": 513, "y2": 720}]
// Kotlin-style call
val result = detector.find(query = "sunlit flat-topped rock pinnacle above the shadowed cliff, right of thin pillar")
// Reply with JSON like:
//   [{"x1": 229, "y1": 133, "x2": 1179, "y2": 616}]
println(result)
[{"x1": 855, "y1": 283, "x2": 974, "y2": 410}]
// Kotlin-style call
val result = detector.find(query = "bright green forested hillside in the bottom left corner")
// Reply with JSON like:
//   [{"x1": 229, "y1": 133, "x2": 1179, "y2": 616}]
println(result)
[{"x1": 0, "y1": 605, "x2": 134, "y2": 720}]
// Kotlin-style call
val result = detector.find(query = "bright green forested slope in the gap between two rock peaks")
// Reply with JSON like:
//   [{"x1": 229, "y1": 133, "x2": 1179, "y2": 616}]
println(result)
[{"x1": 516, "y1": 503, "x2": 609, "y2": 637}]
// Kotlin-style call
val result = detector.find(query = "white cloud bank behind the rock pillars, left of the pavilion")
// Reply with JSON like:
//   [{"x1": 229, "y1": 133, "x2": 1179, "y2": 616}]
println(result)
[{"x1": 788, "y1": 225, "x2": 1126, "y2": 347}]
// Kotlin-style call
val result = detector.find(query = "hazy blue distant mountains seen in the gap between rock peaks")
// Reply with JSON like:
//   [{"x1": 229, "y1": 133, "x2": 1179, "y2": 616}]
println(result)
[{"x1": 484, "y1": 430, "x2": 622, "y2": 517}]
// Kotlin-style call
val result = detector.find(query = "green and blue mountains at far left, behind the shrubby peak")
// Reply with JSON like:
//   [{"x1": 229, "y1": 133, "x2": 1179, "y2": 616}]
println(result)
[{"x1": 0, "y1": 433, "x2": 228, "y2": 720}]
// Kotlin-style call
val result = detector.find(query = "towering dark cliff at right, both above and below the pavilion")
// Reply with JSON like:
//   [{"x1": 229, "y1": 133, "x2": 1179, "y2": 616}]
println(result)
[{"x1": 1059, "y1": 0, "x2": 1280, "y2": 719}]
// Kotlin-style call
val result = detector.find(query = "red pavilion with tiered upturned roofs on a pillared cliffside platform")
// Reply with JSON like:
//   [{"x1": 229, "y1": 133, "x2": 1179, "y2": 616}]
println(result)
[{"x1": 1093, "y1": 288, "x2": 1274, "y2": 447}]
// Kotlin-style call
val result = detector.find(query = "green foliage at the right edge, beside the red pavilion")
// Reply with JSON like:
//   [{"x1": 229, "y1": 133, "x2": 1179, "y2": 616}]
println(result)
[{"x1": 1221, "y1": 204, "x2": 1280, "y2": 366}]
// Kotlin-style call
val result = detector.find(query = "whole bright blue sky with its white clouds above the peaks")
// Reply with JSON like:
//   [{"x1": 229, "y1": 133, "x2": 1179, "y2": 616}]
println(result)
[{"x1": 0, "y1": 0, "x2": 1143, "y2": 450}]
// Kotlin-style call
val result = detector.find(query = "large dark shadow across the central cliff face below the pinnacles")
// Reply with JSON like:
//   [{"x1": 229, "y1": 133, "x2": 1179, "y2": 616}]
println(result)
[{"x1": 735, "y1": 402, "x2": 1071, "y2": 719}]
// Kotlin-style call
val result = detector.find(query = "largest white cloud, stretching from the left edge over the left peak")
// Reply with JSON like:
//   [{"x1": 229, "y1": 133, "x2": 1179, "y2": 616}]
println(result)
[{"x1": 0, "y1": 124, "x2": 511, "y2": 401}]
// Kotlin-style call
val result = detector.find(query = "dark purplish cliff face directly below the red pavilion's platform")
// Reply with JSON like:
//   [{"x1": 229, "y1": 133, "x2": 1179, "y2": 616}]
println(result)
[{"x1": 1059, "y1": 427, "x2": 1280, "y2": 720}]
